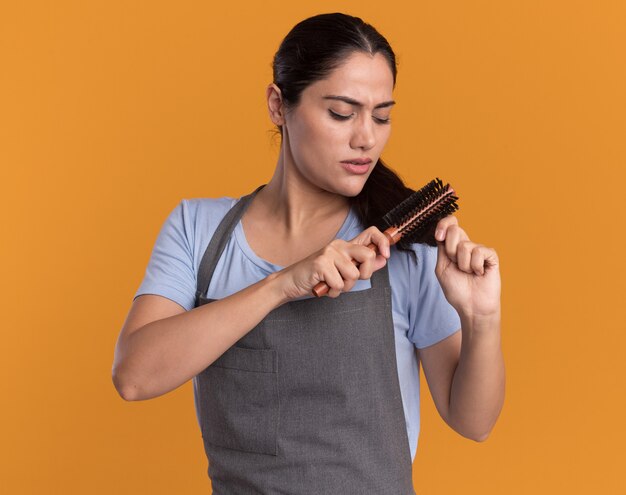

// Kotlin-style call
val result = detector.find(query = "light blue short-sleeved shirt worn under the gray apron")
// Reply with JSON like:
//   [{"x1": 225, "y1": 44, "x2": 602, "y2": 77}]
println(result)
[{"x1": 135, "y1": 198, "x2": 461, "y2": 459}]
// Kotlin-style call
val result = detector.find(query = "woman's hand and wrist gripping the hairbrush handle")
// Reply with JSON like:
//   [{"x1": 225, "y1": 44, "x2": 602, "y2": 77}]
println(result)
[{"x1": 275, "y1": 227, "x2": 390, "y2": 302}]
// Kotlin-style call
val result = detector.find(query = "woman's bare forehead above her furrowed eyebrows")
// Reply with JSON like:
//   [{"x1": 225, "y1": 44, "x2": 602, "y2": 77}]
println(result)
[{"x1": 302, "y1": 52, "x2": 393, "y2": 105}]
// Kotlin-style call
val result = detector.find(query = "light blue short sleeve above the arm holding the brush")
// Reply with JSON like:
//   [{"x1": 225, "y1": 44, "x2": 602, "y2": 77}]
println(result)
[{"x1": 135, "y1": 200, "x2": 196, "y2": 310}]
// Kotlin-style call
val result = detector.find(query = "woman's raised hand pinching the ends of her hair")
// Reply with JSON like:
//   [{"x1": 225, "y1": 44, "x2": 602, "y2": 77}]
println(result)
[{"x1": 435, "y1": 215, "x2": 501, "y2": 318}]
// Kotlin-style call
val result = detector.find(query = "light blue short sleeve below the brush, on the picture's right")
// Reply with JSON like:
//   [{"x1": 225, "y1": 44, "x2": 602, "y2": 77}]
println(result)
[{"x1": 408, "y1": 244, "x2": 461, "y2": 348}]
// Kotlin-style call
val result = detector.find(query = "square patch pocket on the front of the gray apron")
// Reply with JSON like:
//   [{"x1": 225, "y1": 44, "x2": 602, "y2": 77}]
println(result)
[{"x1": 196, "y1": 346, "x2": 278, "y2": 455}]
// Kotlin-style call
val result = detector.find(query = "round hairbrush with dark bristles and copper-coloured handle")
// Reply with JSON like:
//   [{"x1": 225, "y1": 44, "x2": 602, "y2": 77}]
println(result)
[{"x1": 313, "y1": 178, "x2": 459, "y2": 297}]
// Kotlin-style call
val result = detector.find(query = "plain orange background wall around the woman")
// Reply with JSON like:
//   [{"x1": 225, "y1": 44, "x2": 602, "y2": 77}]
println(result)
[{"x1": 0, "y1": 0, "x2": 626, "y2": 494}]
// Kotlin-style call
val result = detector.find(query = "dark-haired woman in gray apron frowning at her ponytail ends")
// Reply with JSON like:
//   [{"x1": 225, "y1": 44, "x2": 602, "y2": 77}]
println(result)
[{"x1": 113, "y1": 14, "x2": 504, "y2": 495}]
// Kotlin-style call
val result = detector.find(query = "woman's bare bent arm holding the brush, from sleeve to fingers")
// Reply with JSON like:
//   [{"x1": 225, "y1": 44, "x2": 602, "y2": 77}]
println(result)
[{"x1": 112, "y1": 228, "x2": 389, "y2": 400}]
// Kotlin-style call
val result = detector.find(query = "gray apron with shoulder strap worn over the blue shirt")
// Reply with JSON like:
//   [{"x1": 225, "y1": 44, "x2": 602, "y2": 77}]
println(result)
[{"x1": 194, "y1": 188, "x2": 417, "y2": 495}]
